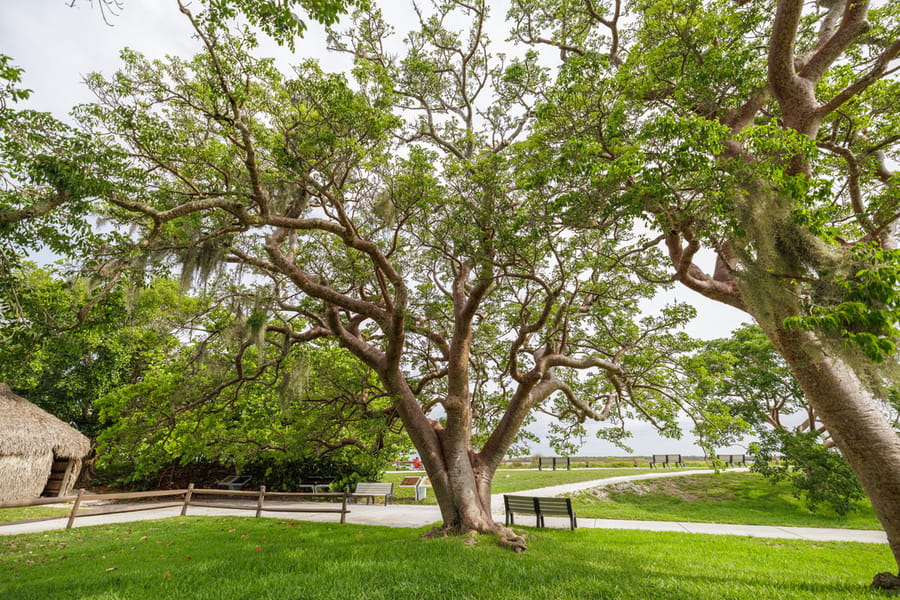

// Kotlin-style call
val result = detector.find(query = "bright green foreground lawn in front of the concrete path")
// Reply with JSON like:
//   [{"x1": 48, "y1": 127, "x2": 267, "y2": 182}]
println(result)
[{"x1": 0, "y1": 517, "x2": 896, "y2": 600}]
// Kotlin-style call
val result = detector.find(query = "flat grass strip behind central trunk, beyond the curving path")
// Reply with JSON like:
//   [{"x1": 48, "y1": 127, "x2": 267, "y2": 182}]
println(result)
[{"x1": 382, "y1": 467, "x2": 659, "y2": 504}]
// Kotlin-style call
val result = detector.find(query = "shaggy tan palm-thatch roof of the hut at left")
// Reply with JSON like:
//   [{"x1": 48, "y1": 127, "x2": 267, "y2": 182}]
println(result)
[{"x1": 0, "y1": 382, "x2": 91, "y2": 459}]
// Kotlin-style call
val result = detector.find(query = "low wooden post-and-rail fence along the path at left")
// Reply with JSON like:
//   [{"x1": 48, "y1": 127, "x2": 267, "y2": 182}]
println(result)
[{"x1": 0, "y1": 483, "x2": 350, "y2": 529}]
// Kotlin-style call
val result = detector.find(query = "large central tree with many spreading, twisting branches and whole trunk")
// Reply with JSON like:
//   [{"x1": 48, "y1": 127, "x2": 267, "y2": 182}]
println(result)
[{"x1": 79, "y1": 2, "x2": 690, "y2": 549}]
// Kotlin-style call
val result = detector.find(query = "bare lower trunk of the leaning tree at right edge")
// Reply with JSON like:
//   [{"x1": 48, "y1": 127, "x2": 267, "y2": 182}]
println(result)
[{"x1": 763, "y1": 324, "x2": 900, "y2": 580}]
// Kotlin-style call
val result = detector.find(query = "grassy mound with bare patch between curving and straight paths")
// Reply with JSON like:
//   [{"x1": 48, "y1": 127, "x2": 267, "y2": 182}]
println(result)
[{"x1": 572, "y1": 472, "x2": 881, "y2": 529}]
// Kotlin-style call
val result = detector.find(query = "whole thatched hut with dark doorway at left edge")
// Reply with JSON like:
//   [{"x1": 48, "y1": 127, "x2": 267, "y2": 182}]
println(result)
[{"x1": 0, "y1": 383, "x2": 91, "y2": 502}]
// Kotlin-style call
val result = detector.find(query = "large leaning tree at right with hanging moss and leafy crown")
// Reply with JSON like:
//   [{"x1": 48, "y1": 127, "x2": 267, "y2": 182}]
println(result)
[{"x1": 511, "y1": 0, "x2": 900, "y2": 585}]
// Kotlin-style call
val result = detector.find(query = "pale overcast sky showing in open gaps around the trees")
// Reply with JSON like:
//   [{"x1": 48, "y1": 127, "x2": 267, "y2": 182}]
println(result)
[{"x1": 0, "y1": 0, "x2": 750, "y2": 456}]
